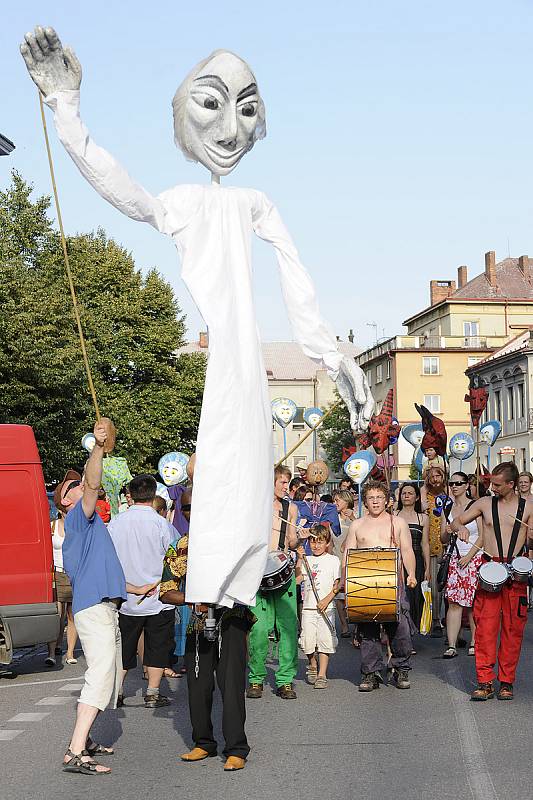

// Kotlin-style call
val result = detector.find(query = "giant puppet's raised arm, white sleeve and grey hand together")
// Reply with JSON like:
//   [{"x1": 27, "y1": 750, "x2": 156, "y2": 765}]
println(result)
[{"x1": 20, "y1": 27, "x2": 165, "y2": 231}]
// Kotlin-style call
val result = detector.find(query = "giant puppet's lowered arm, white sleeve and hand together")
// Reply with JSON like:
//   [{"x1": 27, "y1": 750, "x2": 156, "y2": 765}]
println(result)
[{"x1": 253, "y1": 192, "x2": 374, "y2": 433}]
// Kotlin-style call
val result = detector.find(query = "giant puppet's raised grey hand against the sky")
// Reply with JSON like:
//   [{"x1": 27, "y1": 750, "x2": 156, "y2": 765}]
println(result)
[{"x1": 20, "y1": 25, "x2": 81, "y2": 97}]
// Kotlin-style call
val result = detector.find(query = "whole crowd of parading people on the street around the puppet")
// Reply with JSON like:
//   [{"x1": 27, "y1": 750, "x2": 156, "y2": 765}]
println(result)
[{"x1": 46, "y1": 423, "x2": 533, "y2": 774}]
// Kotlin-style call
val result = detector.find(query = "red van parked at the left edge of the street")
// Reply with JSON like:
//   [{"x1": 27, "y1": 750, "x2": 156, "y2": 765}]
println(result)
[{"x1": 0, "y1": 425, "x2": 59, "y2": 664}]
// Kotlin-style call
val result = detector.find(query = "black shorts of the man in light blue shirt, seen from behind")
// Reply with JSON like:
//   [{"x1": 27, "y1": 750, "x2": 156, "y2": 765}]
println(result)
[{"x1": 118, "y1": 608, "x2": 175, "y2": 669}]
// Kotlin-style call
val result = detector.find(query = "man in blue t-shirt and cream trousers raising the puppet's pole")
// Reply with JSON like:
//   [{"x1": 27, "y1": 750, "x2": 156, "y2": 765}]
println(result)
[{"x1": 59, "y1": 420, "x2": 155, "y2": 775}]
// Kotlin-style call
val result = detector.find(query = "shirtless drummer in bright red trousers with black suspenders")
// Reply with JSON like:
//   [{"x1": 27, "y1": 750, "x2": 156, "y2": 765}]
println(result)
[{"x1": 452, "y1": 461, "x2": 533, "y2": 700}]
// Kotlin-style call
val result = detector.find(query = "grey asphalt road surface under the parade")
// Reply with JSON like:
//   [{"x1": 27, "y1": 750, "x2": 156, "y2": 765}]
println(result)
[{"x1": 0, "y1": 622, "x2": 533, "y2": 800}]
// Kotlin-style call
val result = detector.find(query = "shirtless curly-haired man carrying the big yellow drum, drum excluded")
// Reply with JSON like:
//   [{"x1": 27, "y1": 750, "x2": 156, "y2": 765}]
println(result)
[{"x1": 344, "y1": 481, "x2": 416, "y2": 692}]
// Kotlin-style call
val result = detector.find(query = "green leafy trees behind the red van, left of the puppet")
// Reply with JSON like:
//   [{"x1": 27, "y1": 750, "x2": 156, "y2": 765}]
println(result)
[{"x1": 0, "y1": 172, "x2": 205, "y2": 480}]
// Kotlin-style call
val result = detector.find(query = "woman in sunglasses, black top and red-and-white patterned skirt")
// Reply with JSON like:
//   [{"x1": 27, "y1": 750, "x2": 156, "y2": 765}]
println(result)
[{"x1": 441, "y1": 472, "x2": 481, "y2": 658}]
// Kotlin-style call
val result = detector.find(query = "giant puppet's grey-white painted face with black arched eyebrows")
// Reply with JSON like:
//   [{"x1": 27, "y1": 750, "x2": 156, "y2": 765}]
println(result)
[{"x1": 185, "y1": 53, "x2": 261, "y2": 175}]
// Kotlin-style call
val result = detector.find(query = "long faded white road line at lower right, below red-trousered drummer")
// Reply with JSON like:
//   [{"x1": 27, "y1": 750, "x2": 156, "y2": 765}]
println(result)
[{"x1": 444, "y1": 662, "x2": 499, "y2": 800}]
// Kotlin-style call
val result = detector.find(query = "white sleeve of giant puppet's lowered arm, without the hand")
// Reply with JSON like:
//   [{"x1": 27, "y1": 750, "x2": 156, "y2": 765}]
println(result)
[{"x1": 253, "y1": 192, "x2": 343, "y2": 380}]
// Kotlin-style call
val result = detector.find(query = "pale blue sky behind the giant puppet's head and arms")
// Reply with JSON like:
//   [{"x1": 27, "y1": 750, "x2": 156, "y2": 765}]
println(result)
[{"x1": 4, "y1": 0, "x2": 533, "y2": 347}]
